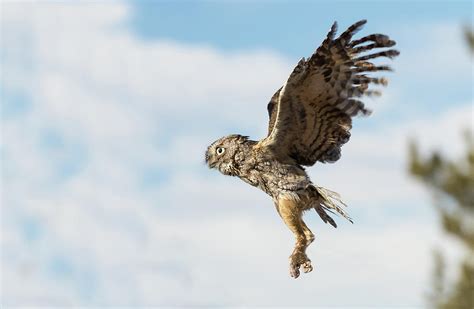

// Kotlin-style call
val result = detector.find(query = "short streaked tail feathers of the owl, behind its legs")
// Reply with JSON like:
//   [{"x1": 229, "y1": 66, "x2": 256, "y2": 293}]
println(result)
[{"x1": 314, "y1": 187, "x2": 353, "y2": 227}]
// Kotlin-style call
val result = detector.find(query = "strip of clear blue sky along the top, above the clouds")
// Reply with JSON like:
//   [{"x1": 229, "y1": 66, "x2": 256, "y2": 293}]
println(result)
[{"x1": 130, "y1": 1, "x2": 472, "y2": 54}]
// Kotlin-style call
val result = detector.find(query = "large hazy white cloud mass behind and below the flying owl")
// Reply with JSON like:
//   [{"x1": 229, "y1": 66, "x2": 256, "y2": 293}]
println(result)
[{"x1": 1, "y1": 3, "x2": 472, "y2": 306}]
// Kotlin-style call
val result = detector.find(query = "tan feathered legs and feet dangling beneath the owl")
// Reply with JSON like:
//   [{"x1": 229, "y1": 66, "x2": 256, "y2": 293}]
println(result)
[{"x1": 277, "y1": 199, "x2": 314, "y2": 278}]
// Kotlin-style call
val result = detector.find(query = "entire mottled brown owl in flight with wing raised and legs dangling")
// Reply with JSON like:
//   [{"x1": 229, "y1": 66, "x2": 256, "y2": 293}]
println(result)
[{"x1": 205, "y1": 20, "x2": 399, "y2": 278}]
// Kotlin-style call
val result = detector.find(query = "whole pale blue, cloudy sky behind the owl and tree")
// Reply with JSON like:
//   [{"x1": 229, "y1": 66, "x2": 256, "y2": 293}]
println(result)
[{"x1": 0, "y1": 1, "x2": 474, "y2": 308}]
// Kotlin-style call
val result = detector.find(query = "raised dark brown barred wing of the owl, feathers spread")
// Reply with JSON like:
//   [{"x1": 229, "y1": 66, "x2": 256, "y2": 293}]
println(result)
[{"x1": 259, "y1": 20, "x2": 399, "y2": 166}]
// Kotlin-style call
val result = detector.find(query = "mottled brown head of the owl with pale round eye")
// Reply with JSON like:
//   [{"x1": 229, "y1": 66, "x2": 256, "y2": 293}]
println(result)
[{"x1": 205, "y1": 134, "x2": 248, "y2": 176}]
